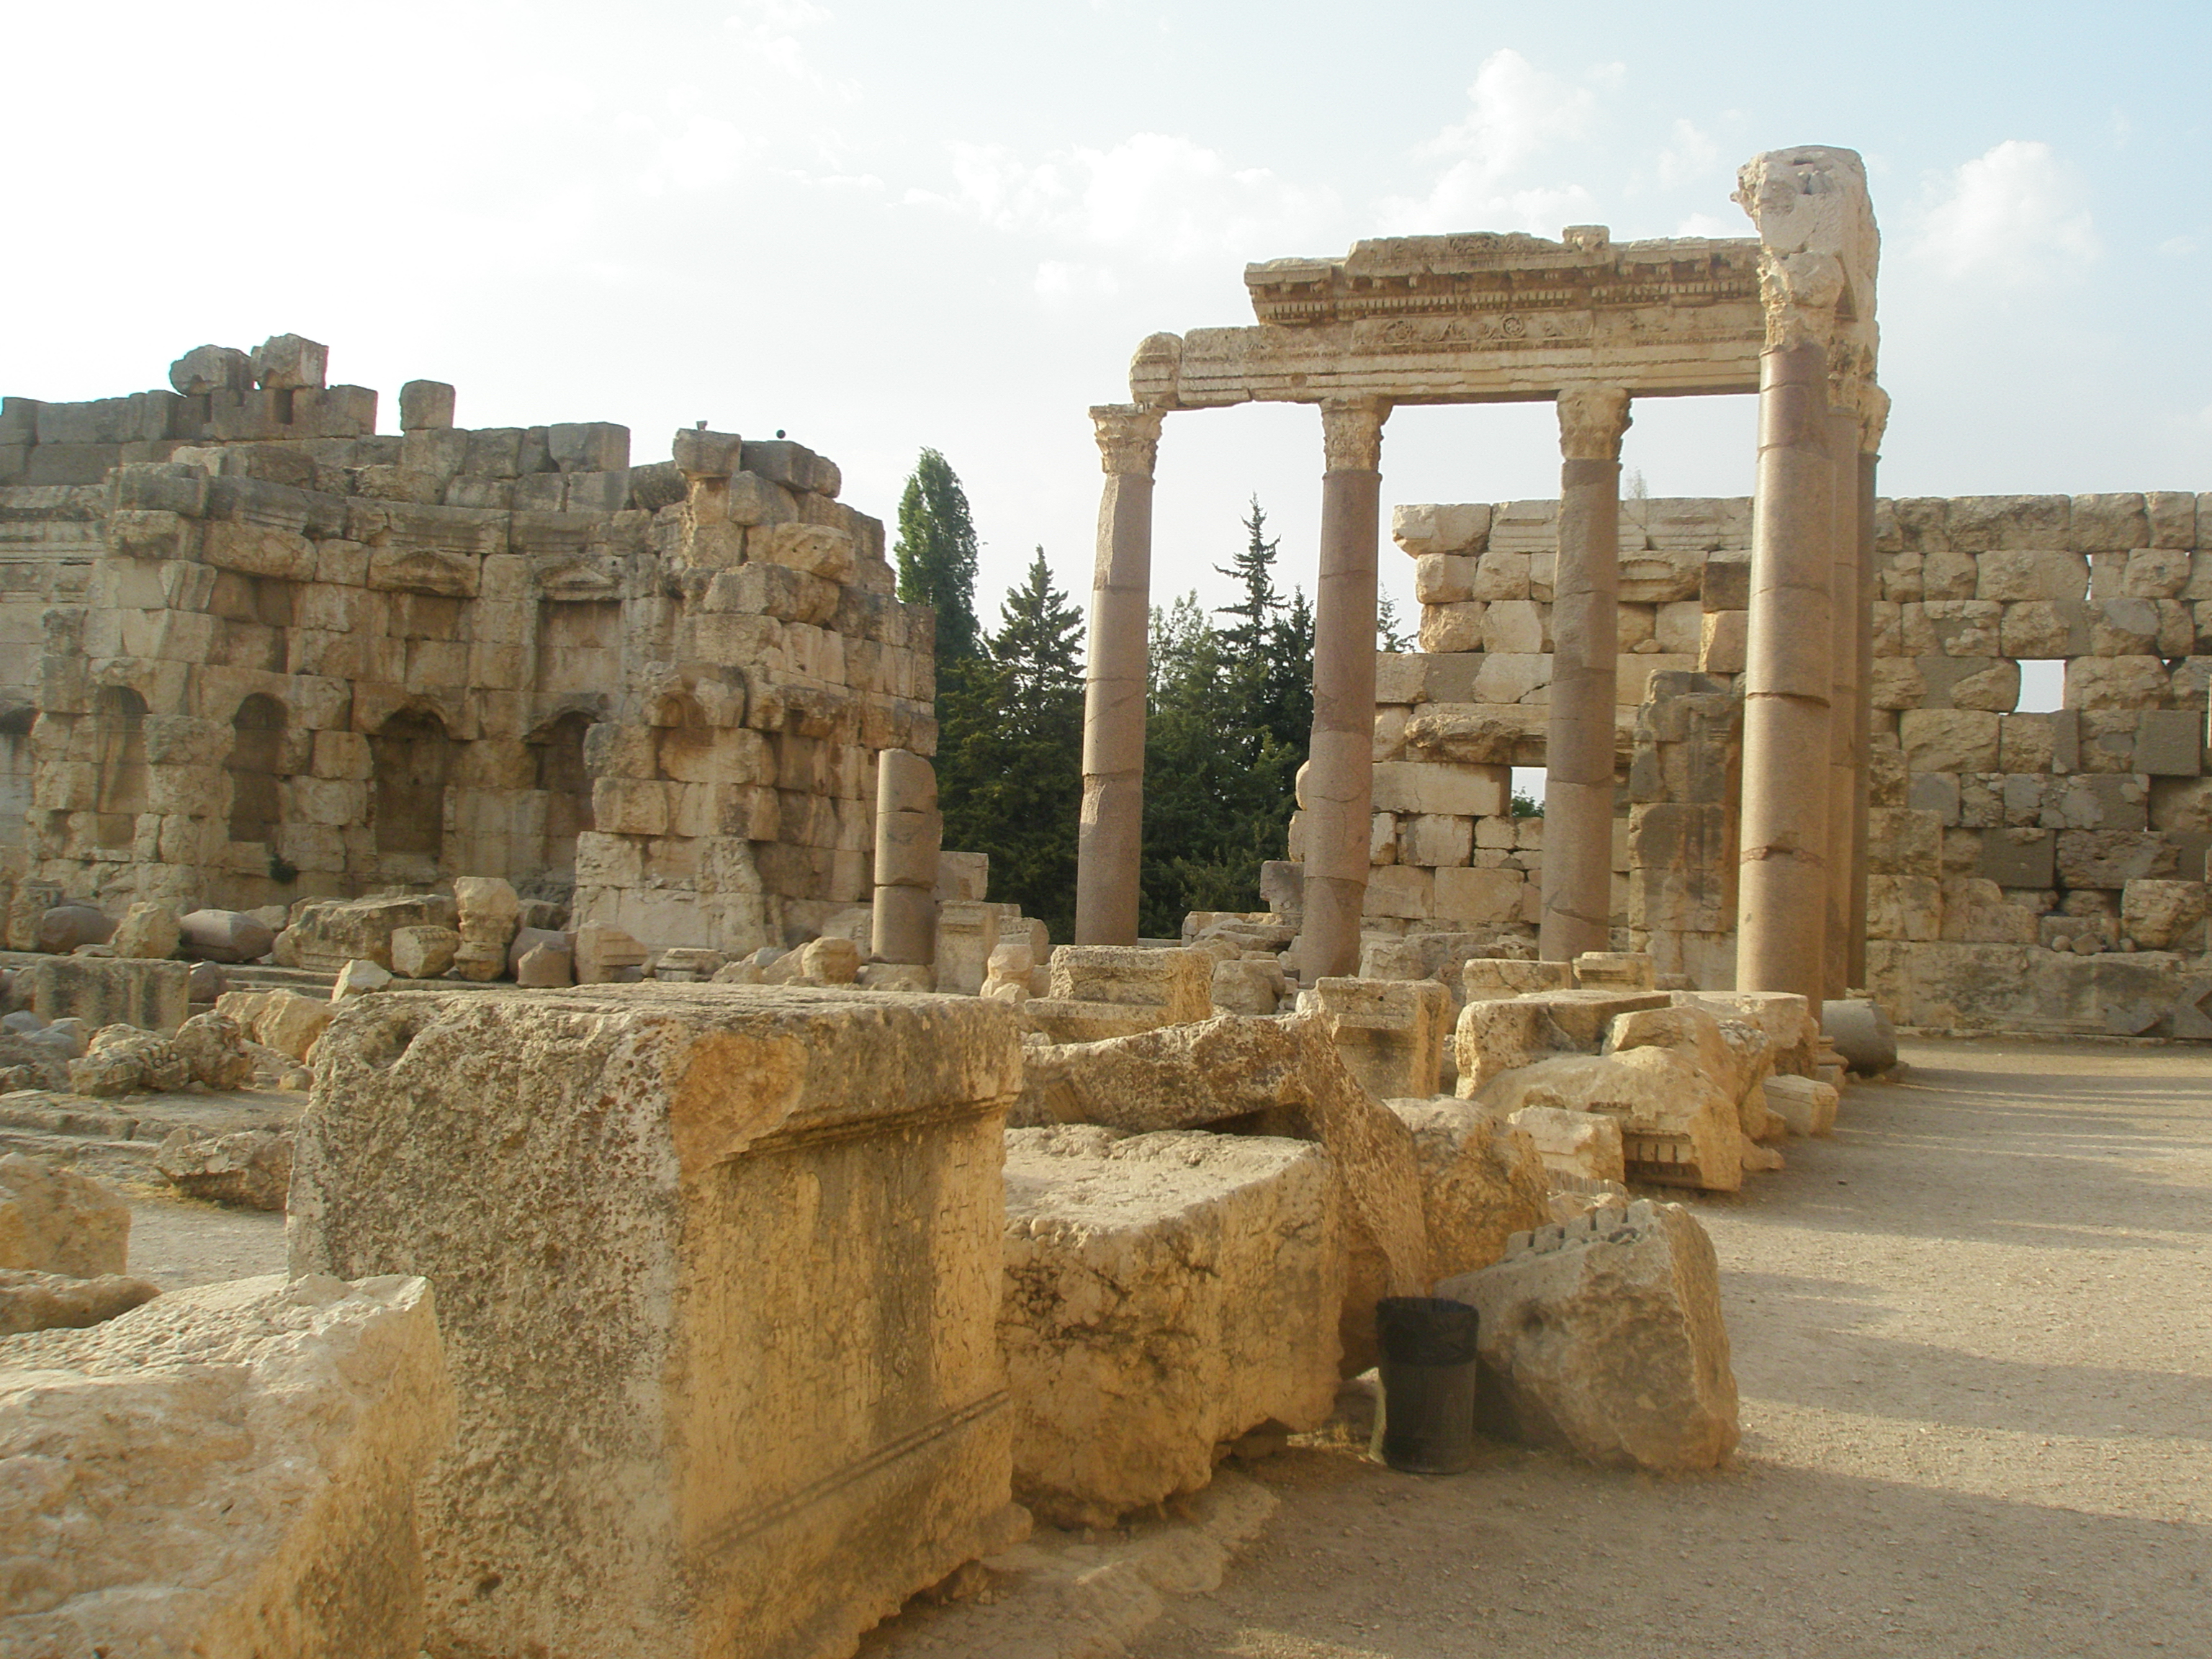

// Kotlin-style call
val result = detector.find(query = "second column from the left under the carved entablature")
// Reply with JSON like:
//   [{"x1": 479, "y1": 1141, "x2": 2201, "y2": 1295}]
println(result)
[{"x1": 1298, "y1": 398, "x2": 1389, "y2": 984}]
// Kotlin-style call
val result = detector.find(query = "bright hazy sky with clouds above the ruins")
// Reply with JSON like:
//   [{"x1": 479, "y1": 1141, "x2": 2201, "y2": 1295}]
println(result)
[{"x1": 0, "y1": 0, "x2": 2212, "y2": 624}]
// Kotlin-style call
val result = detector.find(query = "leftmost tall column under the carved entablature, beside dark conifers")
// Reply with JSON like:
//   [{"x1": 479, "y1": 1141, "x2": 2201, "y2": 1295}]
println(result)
[{"x1": 1075, "y1": 403, "x2": 1159, "y2": 945}]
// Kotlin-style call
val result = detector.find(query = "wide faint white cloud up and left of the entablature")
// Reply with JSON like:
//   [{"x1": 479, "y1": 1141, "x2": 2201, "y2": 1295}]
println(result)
[{"x1": 907, "y1": 132, "x2": 1336, "y2": 258}]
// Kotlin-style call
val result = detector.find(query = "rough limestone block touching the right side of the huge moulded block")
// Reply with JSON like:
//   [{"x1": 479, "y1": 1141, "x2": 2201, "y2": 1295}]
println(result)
[{"x1": 997, "y1": 1128, "x2": 1345, "y2": 1527}]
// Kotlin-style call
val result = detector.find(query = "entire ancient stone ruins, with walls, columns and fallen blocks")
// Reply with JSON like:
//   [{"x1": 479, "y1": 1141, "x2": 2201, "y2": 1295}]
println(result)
[{"x1": 0, "y1": 148, "x2": 2212, "y2": 1659}]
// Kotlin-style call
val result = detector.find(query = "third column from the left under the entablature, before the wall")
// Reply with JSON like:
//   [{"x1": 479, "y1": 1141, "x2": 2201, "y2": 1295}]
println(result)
[{"x1": 1537, "y1": 387, "x2": 1628, "y2": 962}]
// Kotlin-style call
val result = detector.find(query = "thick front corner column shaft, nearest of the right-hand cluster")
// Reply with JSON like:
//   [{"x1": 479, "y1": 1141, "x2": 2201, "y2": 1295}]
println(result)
[{"x1": 1737, "y1": 336, "x2": 1836, "y2": 1009}]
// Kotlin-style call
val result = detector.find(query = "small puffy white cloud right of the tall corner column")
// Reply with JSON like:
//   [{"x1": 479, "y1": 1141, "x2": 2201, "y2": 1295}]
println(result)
[{"x1": 1915, "y1": 140, "x2": 2103, "y2": 285}]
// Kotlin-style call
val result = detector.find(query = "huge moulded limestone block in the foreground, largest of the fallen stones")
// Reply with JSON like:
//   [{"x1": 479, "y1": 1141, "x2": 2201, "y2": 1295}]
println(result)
[{"x1": 287, "y1": 982, "x2": 1022, "y2": 1655}]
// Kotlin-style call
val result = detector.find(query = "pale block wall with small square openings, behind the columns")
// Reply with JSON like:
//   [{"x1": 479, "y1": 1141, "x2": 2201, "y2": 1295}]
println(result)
[{"x1": 1362, "y1": 491, "x2": 2212, "y2": 1035}]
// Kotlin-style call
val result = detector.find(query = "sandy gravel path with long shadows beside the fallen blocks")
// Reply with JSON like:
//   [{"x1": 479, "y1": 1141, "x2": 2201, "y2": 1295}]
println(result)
[{"x1": 1133, "y1": 1042, "x2": 2212, "y2": 1659}]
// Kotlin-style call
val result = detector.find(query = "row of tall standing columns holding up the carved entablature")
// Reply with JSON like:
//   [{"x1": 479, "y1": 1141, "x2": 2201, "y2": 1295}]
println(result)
[{"x1": 1075, "y1": 376, "x2": 1878, "y2": 1002}]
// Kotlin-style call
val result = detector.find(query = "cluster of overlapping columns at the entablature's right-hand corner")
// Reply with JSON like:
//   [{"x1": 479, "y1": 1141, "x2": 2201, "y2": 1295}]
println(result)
[{"x1": 1737, "y1": 338, "x2": 1880, "y2": 1007}]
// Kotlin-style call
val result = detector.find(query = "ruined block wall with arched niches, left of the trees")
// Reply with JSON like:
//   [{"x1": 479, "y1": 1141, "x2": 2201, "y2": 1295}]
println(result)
[{"x1": 0, "y1": 336, "x2": 935, "y2": 951}]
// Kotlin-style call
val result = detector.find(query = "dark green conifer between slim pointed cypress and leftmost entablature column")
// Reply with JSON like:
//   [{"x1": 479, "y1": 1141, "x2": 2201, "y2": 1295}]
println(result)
[{"x1": 938, "y1": 547, "x2": 1084, "y2": 940}]
